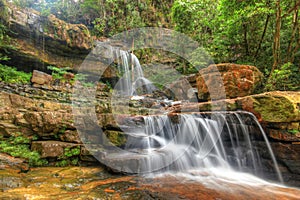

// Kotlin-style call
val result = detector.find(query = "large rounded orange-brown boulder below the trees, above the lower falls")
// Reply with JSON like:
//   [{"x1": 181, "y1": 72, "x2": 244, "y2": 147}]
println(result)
[{"x1": 196, "y1": 63, "x2": 263, "y2": 101}]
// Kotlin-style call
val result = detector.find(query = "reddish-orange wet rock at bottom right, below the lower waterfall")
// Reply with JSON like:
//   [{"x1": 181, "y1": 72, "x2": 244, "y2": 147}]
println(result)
[{"x1": 144, "y1": 175, "x2": 300, "y2": 200}]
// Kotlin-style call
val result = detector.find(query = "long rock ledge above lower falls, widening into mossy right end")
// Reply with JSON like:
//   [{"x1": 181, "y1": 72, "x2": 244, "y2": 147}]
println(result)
[{"x1": 169, "y1": 91, "x2": 300, "y2": 134}]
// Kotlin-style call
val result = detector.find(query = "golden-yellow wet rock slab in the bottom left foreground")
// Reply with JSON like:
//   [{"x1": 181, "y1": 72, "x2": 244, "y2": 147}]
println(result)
[{"x1": 0, "y1": 166, "x2": 177, "y2": 200}]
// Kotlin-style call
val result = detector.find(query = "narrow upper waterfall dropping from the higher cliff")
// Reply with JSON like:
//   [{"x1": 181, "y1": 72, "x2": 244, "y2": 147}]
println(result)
[{"x1": 111, "y1": 49, "x2": 156, "y2": 96}]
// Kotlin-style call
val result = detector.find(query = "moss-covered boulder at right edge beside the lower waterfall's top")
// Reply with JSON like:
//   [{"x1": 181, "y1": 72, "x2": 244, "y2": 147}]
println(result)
[{"x1": 237, "y1": 91, "x2": 300, "y2": 142}]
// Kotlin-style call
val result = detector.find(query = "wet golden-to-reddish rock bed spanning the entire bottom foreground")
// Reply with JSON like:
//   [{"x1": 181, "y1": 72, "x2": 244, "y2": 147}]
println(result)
[{"x1": 0, "y1": 167, "x2": 300, "y2": 200}]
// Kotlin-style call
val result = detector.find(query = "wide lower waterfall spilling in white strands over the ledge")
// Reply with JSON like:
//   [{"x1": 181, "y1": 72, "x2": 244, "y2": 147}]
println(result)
[{"x1": 119, "y1": 111, "x2": 282, "y2": 181}]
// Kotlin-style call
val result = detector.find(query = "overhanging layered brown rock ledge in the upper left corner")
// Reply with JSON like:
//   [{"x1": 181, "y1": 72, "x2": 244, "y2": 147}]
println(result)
[{"x1": 0, "y1": 0, "x2": 92, "y2": 72}]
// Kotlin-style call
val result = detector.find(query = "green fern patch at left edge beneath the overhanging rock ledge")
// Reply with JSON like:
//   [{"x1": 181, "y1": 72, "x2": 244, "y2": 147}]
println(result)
[{"x1": 0, "y1": 65, "x2": 32, "y2": 84}]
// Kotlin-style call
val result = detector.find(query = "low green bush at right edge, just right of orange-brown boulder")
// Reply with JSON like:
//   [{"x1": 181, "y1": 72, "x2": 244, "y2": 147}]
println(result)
[{"x1": 265, "y1": 63, "x2": 300, "y2": 91}]
